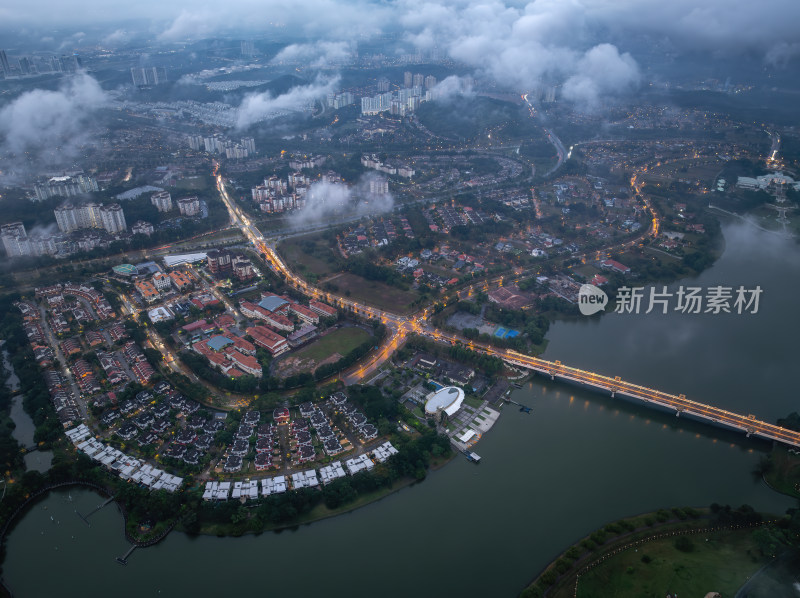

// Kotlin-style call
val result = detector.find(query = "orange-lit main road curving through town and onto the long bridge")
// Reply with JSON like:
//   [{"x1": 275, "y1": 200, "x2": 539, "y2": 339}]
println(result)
[{"x1": 211, "y1": 175, "x2": 800, "y2": 447}]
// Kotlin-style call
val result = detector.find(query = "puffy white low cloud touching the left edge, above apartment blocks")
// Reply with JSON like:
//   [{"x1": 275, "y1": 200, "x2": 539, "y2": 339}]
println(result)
[{"x1": 0, "y1": 73, "x2": 109, "y2": 175}]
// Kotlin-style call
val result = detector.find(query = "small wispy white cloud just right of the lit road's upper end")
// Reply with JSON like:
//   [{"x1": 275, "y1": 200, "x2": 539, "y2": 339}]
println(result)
[{"x1": 291, "y1": 173, "x2": 394, "y2": 227}]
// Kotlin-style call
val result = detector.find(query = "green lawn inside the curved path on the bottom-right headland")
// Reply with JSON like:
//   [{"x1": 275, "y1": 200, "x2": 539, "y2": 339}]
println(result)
[{"x1": 577, "y1": 529, "x2": 763, "y2": 598}]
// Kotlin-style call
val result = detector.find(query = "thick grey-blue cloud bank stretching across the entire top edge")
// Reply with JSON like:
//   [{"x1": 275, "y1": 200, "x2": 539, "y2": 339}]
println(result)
[{"x1": 0, "y1": 0, "x2": 800, "y2": 104}]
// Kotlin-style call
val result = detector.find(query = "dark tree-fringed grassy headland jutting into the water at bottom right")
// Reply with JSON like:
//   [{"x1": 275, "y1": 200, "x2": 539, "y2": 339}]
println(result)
[{"x1": 520, "y1": 505, "x2": 788, "y2": 598}]
